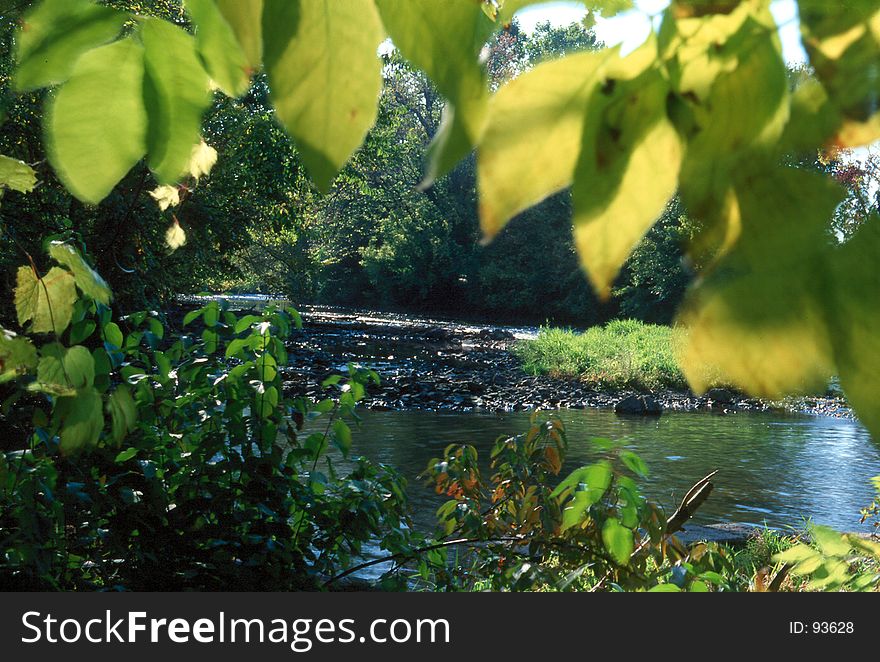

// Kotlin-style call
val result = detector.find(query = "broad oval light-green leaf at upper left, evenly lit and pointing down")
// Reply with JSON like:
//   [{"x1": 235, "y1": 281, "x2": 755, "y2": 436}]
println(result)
[{"x1": 44, "y1": 38, "x2": 147, "y2": 204}]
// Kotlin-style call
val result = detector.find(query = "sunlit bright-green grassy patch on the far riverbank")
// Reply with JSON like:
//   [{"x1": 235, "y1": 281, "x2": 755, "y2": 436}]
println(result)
[{"x1": 514, "y1": 320, "x2": 687, "y2": 391}]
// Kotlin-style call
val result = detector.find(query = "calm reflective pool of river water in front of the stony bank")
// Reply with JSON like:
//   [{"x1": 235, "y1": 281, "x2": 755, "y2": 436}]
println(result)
[{"x1": 344, "y1": 410, "x2": 880, "y2": 531}]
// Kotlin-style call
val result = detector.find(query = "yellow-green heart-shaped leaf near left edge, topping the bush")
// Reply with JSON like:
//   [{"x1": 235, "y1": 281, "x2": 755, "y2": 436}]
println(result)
[{"x1": 15, "y1": 267, "x2": 76, "y2": 335}]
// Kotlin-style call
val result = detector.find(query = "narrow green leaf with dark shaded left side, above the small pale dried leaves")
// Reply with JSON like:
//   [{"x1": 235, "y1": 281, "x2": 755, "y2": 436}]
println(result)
[{"x1": 141, "y1": 19, "x2": 211, "y2": 184}]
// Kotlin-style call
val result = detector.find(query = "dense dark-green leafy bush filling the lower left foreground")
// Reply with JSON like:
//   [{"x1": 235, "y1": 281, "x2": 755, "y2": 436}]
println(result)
[{"x1": 0, "y1": 243, "x2": 409, "y2": 590}]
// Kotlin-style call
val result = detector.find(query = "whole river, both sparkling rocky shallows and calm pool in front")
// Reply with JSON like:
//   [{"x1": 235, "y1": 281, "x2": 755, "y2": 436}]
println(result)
[{"x1": 198, "y1": 299, "x2": 880, "y2": 531}]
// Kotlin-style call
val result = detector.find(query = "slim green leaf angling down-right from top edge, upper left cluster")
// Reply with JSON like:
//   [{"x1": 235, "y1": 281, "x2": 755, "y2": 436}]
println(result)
[{"x1": 185, "y1": 0, "x2": 253, "y2": 97}]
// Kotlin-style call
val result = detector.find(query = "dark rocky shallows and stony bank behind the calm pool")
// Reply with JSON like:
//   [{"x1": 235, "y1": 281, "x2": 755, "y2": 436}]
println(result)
[{"x1": 285, "y1": 308, "x2": 852, "y2": 417}]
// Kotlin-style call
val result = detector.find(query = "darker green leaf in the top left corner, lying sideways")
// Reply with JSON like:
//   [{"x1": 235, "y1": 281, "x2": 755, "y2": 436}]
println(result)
[{"x1": 15, "y1": 0, "x2": 129, "y2": 92}]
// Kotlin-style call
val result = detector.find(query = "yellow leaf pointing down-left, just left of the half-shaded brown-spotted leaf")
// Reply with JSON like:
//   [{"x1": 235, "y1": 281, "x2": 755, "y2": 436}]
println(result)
[{"x1": 477, "y1": 50, "x2": 612, "y2": 238}]
